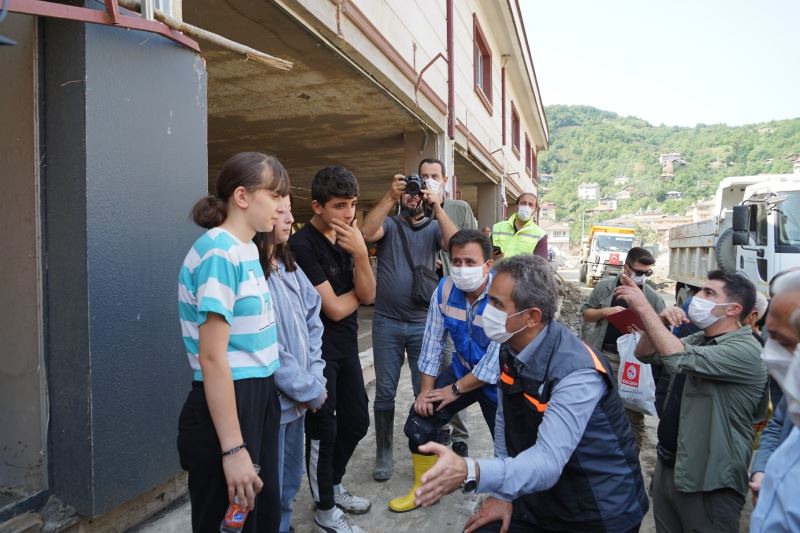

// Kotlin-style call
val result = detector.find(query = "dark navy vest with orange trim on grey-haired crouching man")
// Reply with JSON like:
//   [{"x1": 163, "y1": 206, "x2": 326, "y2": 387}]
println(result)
[{"x1": 500, "y1": 321, "x2": 649, "y2": 531}]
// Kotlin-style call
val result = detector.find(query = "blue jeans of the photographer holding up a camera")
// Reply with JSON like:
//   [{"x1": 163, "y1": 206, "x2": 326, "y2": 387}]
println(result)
[{"x1": 372, "y1": 313, "x2": 425, "y2": 411}]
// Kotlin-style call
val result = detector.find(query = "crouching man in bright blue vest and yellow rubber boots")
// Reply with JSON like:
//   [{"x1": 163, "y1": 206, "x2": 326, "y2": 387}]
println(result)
[{"x1": 389, "y1": 229, "x2": 500, "y2": 513}]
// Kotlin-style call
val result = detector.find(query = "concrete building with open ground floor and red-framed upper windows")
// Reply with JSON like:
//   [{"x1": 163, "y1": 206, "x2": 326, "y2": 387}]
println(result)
[{"x1": 191, "y1": 0, "x2": 548, "y2": 225}]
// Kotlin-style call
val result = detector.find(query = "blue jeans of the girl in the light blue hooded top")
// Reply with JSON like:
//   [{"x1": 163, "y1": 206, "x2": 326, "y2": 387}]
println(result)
[{"x1": 278, "y1": 416, "x2": 305, "y2": 533}]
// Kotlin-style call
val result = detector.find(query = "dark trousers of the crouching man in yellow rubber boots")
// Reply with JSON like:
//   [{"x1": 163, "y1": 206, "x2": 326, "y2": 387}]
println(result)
[{"x1": 405, "y1": 366, "x2": 497, "y2": 453}]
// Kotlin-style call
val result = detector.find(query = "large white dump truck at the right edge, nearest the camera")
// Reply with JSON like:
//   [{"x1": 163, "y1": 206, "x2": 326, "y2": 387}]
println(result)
[{"x1": 669, "y1": 173, "x2": 800, "y2": 305}]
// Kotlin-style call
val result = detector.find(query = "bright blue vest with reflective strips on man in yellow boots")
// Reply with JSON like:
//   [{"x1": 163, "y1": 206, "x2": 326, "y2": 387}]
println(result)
[{"x1": 436, "y1": 272, "x2": 497, "y2": 404}]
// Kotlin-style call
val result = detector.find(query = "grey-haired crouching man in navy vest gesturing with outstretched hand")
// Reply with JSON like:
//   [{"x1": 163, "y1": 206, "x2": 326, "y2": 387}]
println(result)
[{"x1": 415, "y1": 255, "x2": 648, "y2": 533}]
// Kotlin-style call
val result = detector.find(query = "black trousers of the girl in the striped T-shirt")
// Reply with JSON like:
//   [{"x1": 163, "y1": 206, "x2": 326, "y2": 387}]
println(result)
[{"x1": 178, "y1": 377, "x2": 281, "y2": 533}]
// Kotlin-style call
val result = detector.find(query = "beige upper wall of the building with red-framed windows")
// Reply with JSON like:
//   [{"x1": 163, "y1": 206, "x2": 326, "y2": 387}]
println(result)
[{"x1": 282, "y1": 0, "x2": 547, "y2": 197}]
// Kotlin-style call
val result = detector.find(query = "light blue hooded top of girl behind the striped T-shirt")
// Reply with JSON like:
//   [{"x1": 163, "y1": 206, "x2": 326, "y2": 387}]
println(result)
[{"x1": 267, "y1": 260, "x2": 326, "y2": 424}]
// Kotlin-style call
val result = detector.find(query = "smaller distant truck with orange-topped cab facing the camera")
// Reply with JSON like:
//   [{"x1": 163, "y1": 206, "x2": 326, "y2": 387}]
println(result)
[{"x1": 578, "y1": 226, "x2": 635, "y2": 287}]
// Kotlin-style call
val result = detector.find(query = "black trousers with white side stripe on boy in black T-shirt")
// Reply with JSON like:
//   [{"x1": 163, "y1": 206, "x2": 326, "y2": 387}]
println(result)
[{"x1": 306, "y1": 357, "x2": 369, "y2": 510}]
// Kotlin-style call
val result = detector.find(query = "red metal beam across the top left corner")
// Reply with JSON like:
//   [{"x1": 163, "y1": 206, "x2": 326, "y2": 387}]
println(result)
[{"x1": 8, "y1": 0, "x2": 200, "y2": 52}]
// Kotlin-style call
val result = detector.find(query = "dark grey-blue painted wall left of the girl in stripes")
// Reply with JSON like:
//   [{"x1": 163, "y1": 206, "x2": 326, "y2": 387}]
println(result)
[{"x1": 44, "y1": 16, "x2": 208, "y2": 516}]
